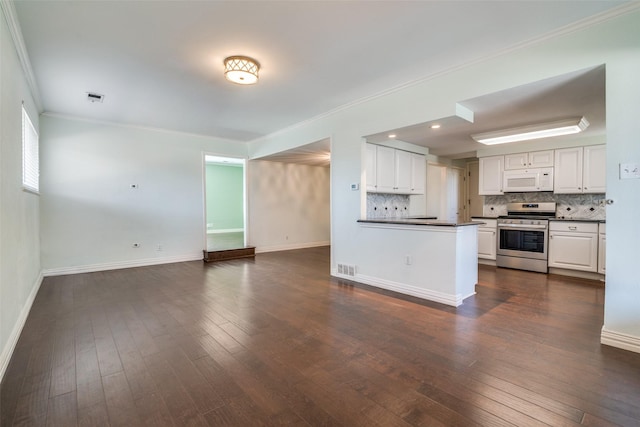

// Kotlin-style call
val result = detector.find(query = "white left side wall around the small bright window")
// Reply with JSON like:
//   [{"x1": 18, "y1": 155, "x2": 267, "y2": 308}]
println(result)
[{"x1": 0, "y1": 5, "x2": 42, "y2": 379}]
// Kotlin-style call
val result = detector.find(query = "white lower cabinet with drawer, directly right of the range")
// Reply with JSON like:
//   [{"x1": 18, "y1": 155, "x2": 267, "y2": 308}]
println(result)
[{"x1": 549, "y1": 221, "x2": 598, "y2": 273}]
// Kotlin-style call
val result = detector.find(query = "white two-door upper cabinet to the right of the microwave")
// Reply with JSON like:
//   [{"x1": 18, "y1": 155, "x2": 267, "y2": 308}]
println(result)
[{"x1": 553, "y1": 145, "x2": 606, "y2": 194}]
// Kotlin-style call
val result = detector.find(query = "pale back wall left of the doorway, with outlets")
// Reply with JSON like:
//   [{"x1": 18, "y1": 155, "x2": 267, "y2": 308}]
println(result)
[{"x1": 40, "y1": 115, "x2": 246, "y2": 274}]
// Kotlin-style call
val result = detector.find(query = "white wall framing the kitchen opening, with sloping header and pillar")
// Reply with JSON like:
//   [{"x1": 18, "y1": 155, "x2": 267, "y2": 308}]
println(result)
[{"x1": 249, "y1": 5, "x2": 640, "y2": 351}]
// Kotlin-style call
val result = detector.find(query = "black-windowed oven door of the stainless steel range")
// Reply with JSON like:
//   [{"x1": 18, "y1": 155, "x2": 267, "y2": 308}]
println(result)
[{"x1": 497, "y1": 223, "x2": 548, "y2": 260}]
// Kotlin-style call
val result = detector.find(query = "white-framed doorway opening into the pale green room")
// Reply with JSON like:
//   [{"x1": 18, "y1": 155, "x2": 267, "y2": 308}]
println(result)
[{"x1": 204, "y1": 154, "x2": 246, "y2": 252}]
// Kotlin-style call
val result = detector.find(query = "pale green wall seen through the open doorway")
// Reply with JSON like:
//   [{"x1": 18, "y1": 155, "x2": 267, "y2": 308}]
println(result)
[{"x1": 206, "y1": 164, "x2": 244, "y2": 230}]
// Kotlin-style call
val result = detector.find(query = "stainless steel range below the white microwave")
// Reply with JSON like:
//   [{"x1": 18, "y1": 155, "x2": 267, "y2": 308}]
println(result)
[{"x1": 496, "y1": 202, "x2": 556, "y2": 273}]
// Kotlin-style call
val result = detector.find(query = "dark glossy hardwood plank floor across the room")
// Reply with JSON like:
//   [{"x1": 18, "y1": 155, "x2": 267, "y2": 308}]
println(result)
[{"x1": 0, "y1": 248, "x2": 640, "y2": 427}]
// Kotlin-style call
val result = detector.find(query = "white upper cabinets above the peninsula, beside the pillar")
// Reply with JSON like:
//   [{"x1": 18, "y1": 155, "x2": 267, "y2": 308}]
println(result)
[{"x1": 366, "y1": 144, "x2": 426, "y2": 194}]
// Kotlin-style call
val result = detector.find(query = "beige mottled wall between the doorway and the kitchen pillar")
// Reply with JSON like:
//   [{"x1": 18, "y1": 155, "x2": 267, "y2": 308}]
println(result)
[{"x1": 247, "y1": 160, "x2": 331, "y2": 252}]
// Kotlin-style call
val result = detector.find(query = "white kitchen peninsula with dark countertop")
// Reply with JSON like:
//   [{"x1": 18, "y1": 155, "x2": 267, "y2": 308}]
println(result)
[{"x1": 352, "y1": 218, "x2": 479, "y2": 307}]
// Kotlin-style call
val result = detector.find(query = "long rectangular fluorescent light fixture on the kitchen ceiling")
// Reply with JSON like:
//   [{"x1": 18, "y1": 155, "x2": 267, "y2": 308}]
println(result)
[{"x1": 471, "y1": 117, "x2": 589, "y2": 145}]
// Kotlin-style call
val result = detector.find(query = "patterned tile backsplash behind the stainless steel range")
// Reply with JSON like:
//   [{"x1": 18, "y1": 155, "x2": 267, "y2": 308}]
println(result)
[{"x1": 483, "y1": 192, "x2": 605, "y2": 220}]
